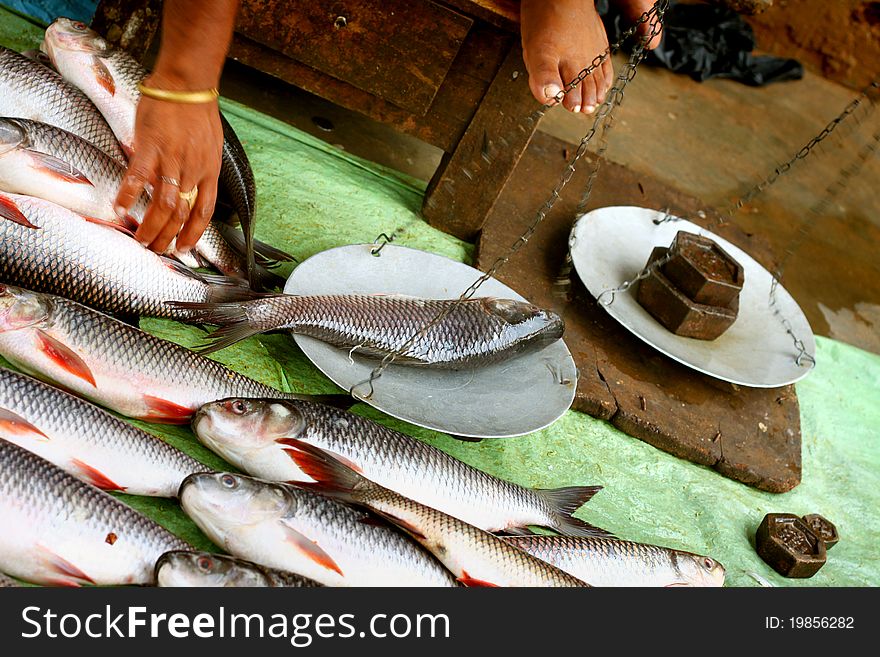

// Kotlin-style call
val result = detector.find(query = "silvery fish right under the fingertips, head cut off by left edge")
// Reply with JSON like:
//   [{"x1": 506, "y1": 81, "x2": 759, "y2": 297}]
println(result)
[{"x1": 0, "y1": 192, "x2": 254, "y2": 320}]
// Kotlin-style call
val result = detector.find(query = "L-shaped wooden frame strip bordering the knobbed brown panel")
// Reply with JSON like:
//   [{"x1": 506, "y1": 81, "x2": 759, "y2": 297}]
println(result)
[{"x1": 230, "y1": 25, "x2": 511, "y2": 152}]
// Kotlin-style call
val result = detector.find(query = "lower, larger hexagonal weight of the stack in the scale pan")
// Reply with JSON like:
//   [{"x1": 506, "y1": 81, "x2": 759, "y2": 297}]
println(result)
[{"x1": 636, "y1": 246, "x2": 739, "y2": 340}]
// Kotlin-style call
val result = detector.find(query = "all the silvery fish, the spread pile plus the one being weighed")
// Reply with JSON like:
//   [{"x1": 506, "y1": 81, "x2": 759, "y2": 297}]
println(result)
[{"x1": 0, "y1": 19, "x2": 724, "y2": 587}]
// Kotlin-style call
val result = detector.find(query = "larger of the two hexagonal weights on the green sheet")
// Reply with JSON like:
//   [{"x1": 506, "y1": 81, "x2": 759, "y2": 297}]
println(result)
[{"x1": 755, "y1": 513, "x2": 826, "y2": 578}]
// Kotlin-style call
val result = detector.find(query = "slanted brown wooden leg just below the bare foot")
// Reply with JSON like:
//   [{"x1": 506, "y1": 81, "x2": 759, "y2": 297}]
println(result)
[{"x1": 422, "y1": 45, "x2": 538, "y2": 240}]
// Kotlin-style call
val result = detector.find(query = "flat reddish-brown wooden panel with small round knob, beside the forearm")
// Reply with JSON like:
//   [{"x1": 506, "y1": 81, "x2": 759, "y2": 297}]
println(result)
[{"x1": 236, "y1": 0, "x2": 473, "y2": 115}]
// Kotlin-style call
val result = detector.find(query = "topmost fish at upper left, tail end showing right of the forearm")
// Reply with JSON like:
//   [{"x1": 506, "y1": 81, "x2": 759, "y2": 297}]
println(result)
[{"x1": 42, "y1": 18, "x2": 261, "y2": 286}]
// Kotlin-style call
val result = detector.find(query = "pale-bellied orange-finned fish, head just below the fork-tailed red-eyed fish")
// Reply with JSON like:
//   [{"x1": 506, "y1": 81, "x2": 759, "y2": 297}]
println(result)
[{"x1": 180, "y1": 473, "x2": 458, "y2": 586}]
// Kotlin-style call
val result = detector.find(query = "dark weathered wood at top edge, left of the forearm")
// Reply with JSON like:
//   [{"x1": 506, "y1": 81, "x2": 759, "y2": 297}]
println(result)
[{"x1": 92, "y1": 0, "x2": 162, "y2": 61}]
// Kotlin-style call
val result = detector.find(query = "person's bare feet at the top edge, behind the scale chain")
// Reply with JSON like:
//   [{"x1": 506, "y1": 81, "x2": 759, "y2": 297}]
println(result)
[{"x1": 520, "y1": 0, "x2": 659, "y2": 114}]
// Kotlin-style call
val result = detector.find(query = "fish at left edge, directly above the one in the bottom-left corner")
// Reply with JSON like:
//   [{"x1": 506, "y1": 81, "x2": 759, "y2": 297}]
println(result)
[{"x1": 0, "y1": 367, "x2": 211, "y2": 497}]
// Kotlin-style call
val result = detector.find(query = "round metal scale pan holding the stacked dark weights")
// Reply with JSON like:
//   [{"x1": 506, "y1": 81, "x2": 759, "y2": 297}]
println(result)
[{"x1": 569, "y1": 206, "x2": 816, "y2": 388}]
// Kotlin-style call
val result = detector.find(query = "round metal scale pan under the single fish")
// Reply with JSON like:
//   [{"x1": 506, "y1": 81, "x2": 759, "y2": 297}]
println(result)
[{"x1": 284, "y1": 244, "x2": 577, "y2": 438}]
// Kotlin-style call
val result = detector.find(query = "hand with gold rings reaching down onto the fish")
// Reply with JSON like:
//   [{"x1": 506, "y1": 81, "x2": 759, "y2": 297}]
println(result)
[{"x1": 115, "y1": 74, "x2": 223, "y2": 253}]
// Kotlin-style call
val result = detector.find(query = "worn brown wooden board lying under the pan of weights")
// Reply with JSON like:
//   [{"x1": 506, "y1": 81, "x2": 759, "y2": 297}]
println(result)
[{"x1": 476, "y1": 132, "x2": 801, "y2": 493}]
